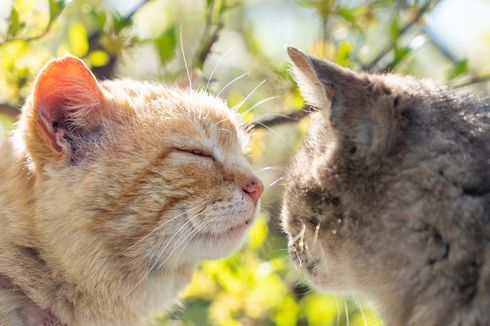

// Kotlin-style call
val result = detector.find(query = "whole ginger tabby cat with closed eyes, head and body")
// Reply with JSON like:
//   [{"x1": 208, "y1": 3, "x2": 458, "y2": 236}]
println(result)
[{"x1": 0, "y1": 56, "x2": 263, "y2": 326}]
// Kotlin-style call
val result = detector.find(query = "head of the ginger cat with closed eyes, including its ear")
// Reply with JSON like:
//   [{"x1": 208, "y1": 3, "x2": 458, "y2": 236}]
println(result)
[{"x1": 16, "y1": 56, "x2": 263, "y2": 291}]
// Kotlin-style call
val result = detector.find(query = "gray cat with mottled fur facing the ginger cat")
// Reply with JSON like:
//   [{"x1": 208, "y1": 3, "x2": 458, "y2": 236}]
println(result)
[{"x1": 283, "y1": 48, "x2": 490, "y2": 326}]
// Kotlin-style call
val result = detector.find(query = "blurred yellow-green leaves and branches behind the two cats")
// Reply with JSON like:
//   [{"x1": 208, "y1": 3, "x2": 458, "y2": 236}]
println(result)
[{"x1": 0, "y1": 0, "x2": 490, "y2": 326}]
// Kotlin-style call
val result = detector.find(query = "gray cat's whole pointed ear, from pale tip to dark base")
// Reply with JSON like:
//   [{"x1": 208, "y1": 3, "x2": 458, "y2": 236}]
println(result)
[{"x1": 287, "y1": 47, "x2": 399, "y2": 157}]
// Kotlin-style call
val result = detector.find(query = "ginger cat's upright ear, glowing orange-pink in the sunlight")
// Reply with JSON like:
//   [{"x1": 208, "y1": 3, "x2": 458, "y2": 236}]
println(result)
[{"x1": 32, "y1": 56, "x2": 104, "y2": 153}]
